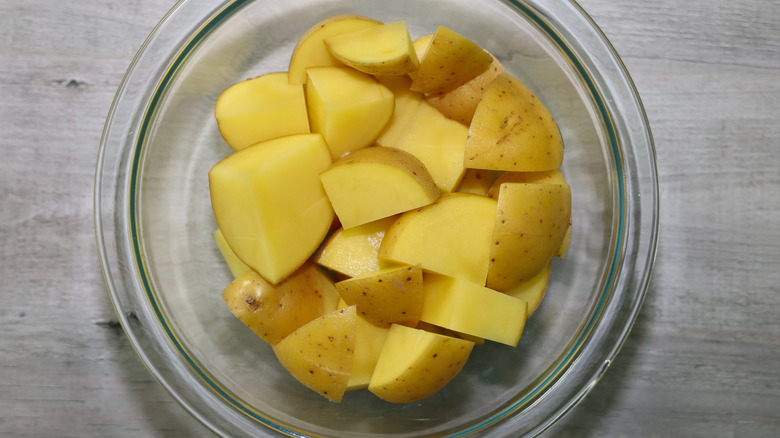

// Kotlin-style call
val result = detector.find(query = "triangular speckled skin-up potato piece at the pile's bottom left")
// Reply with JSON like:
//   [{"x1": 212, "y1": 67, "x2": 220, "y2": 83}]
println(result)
[{"x1": 273, "y1": 307, "x2": 357, "y2": 402}]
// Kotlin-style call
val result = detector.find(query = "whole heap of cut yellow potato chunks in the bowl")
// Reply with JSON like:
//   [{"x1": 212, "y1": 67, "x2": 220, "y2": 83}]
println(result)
[{"x1": 209, "y1": 15, "x2": 571, "y2": 403}]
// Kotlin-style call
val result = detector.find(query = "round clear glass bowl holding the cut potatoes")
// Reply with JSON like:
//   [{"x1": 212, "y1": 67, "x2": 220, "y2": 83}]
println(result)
[{"x1": 95, "y1": 0, "x2": 658, "y2": 438}]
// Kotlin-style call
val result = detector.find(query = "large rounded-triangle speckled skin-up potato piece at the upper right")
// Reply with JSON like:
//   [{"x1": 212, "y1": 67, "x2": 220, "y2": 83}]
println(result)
[{"x1": 465, "y1": 73, "x2": 563, "y2": 172}]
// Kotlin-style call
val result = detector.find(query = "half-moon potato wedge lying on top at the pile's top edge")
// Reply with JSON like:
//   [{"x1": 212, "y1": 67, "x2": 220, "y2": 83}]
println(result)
[{"x1": 325, "y1": 21, "x2": 420, "y2": 76}]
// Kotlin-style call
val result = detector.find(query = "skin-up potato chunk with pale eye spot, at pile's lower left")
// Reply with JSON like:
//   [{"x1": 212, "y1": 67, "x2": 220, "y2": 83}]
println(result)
[{"x1": 222, "y1": 262, "x2": 339, "y2": 345}]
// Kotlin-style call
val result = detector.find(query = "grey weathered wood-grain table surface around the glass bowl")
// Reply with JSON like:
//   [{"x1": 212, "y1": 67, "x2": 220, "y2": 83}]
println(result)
[{"x1": 0, "y1": 0, "x2": 780, "y2": 437}]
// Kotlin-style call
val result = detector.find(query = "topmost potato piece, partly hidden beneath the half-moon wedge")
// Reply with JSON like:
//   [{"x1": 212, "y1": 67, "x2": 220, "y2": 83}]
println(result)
[{"x1": 288, "y1": 15, "x2": 382, "y2": 85}]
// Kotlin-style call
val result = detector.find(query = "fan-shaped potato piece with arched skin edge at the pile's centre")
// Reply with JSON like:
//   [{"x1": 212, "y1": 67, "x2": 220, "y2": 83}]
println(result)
[{"x1": 320, "y1": 146, "x2": 441, "y2": 229}]
